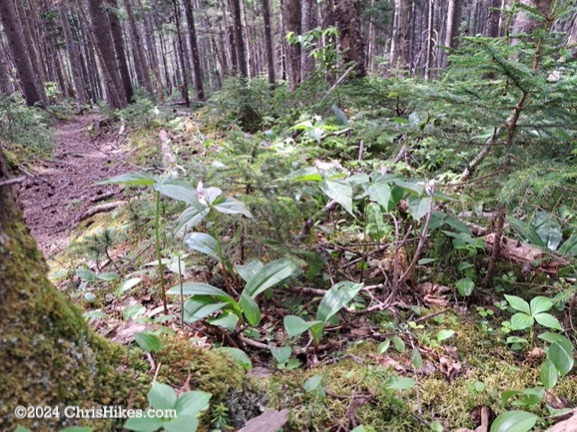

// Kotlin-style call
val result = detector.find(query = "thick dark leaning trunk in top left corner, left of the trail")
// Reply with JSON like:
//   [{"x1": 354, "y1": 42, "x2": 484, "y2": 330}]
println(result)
[{"x1": 0, "y1": 0, "x2": 48, "y2": 106}]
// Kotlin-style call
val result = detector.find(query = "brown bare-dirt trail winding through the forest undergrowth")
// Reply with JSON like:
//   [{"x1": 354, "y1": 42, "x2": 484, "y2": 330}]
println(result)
[{"x1": 18, "y1": 115, "x2": 132, "y2": 257}]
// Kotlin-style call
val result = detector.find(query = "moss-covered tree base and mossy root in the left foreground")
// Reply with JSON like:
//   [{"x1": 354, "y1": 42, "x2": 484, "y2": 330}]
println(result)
[{"x1": 0, "y1": 152, "x2": 243, "y2": 431}]
